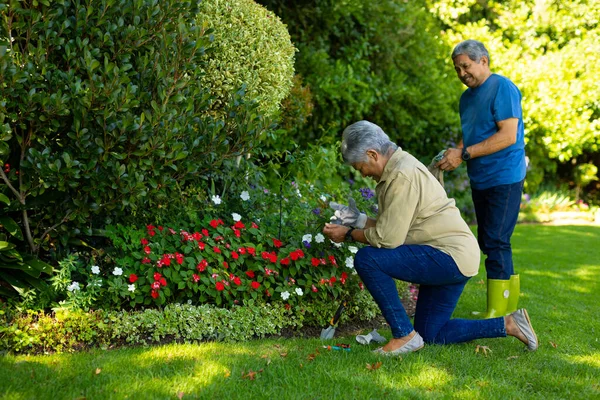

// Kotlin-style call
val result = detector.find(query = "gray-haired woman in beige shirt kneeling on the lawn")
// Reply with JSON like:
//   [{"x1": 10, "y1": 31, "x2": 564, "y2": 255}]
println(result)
[{"x1": 323, "y1": 121, "x2": 538, "y2": 355}]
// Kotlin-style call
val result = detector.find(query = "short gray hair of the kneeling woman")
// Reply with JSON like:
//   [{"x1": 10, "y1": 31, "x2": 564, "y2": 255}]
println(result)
[{"x1": 342, "y1": 121, "x2": 398, "y2": 164}]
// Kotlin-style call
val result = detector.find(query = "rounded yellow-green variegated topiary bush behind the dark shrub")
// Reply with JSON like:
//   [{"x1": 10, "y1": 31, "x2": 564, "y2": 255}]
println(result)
[{"x1": 198, "y1": 0, "x2": 295, "y2": 115}]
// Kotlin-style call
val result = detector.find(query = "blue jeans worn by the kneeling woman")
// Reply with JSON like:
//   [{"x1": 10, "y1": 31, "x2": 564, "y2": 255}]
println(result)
[{"x1": 354, "y1": 245, "x2": 506, "y2": 344}]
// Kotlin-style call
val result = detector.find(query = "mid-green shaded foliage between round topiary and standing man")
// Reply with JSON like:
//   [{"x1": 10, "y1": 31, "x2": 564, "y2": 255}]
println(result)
[{"x1": 260, "y1": 0, "x2": 460, "y2": 157}]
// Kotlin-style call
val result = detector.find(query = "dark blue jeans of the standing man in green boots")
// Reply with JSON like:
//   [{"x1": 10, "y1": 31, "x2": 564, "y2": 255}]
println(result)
[{"x1": 472, "y1": 181, "x2": 524, "y2": 280}]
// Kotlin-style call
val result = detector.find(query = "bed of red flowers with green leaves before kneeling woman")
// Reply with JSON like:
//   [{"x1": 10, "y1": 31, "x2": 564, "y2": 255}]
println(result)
[{"x1": 103, "y1": 213, "x2": 363, "y2": 307}]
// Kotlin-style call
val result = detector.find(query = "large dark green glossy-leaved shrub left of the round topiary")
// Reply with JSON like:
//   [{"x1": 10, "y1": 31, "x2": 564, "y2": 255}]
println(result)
[{"x1": 0, "y1": 0, "x2": 267, "y2": 253}]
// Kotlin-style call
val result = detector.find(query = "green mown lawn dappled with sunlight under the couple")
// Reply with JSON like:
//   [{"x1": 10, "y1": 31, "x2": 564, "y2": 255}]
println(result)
[{"x1": 0, "y1": 225, "x2": 600, "y2": 400}]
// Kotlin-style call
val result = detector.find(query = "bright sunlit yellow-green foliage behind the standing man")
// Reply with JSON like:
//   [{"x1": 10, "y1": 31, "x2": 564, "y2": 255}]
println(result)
[{"x1": 428, "y1": 0, "x2": 600, "y2": 192}]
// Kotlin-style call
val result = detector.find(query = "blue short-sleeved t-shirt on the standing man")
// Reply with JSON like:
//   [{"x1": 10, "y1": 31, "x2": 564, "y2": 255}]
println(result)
[{"x1": 460, "y1": 74, "x2": 526, "y2": 190}]
